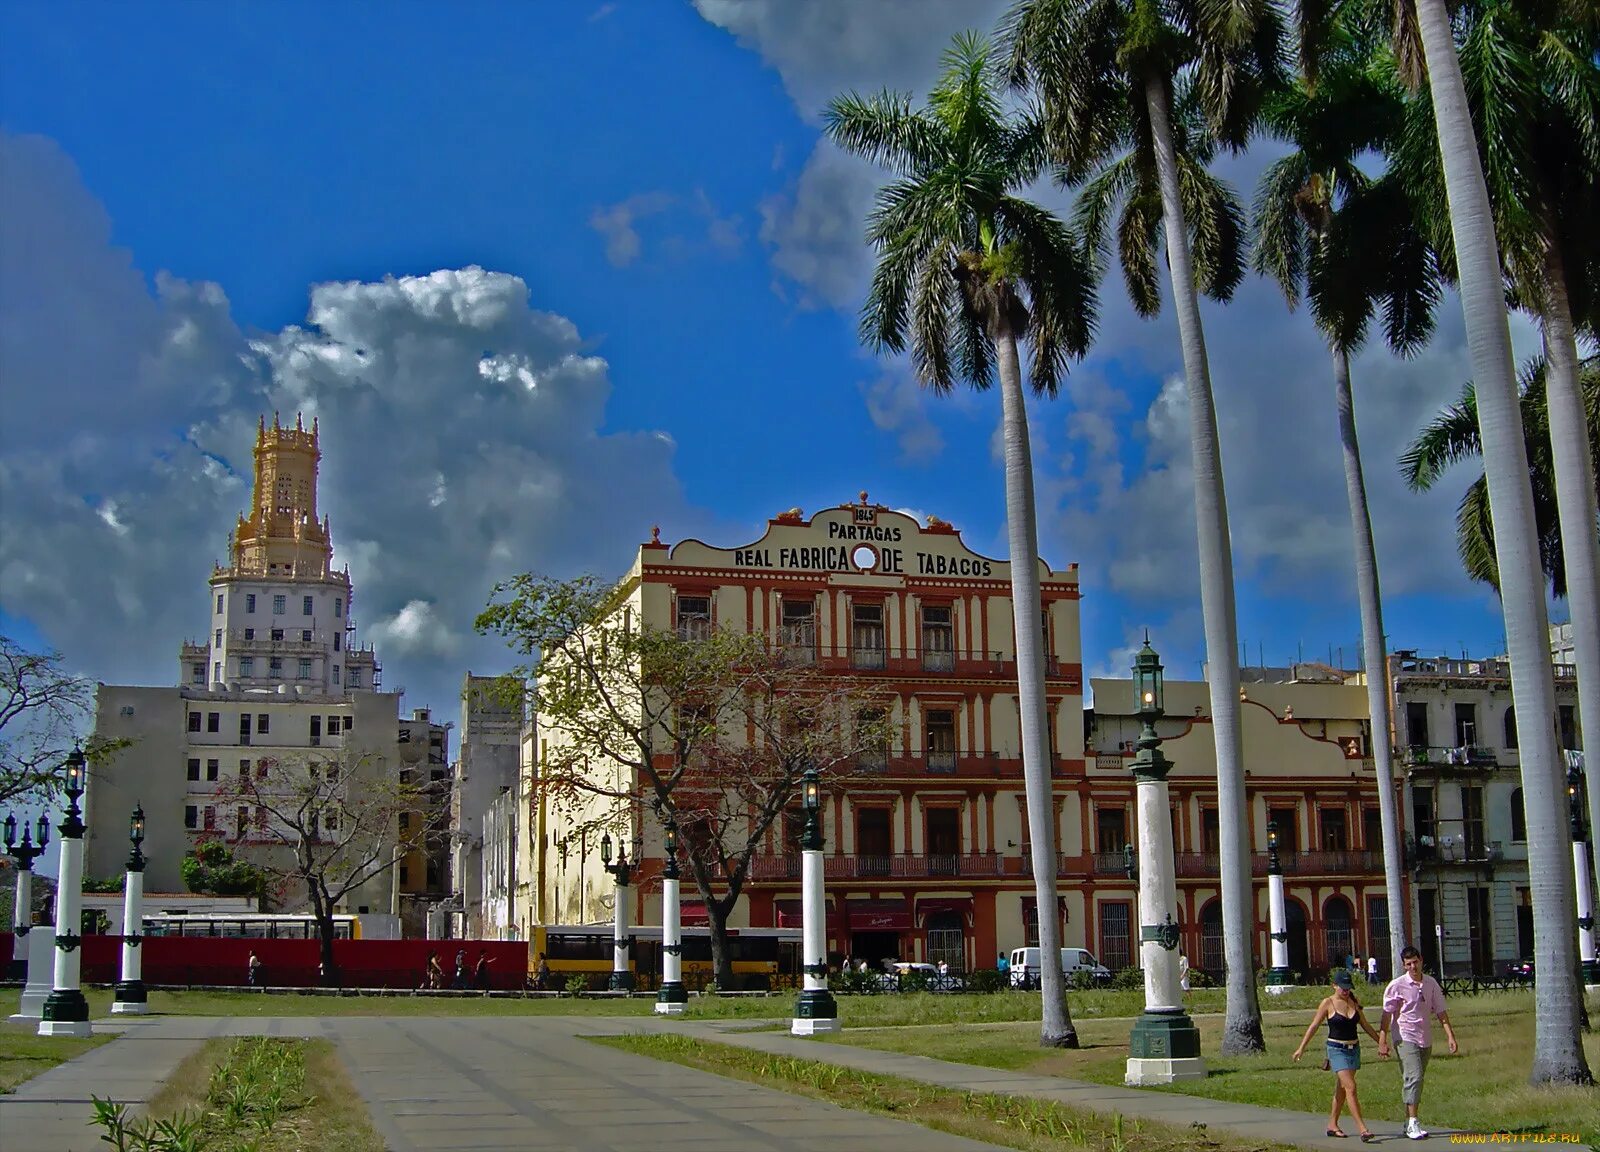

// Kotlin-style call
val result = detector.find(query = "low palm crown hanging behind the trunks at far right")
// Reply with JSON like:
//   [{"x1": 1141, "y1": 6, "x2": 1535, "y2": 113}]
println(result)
[{"x1": 1400, "y1": 357, "x2": 1600, "y2": 602}]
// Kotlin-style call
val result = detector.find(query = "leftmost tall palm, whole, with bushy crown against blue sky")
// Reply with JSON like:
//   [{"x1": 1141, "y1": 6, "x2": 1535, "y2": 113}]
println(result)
[{"x1": 826, "y1": 32, "x2": 1094, "y2": 1048}]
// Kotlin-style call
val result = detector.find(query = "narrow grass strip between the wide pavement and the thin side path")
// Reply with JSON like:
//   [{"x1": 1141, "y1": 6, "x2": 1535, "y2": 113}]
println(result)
[{"x1": 594, "y1": 1035, "x2": 1293, "y2": 1152}]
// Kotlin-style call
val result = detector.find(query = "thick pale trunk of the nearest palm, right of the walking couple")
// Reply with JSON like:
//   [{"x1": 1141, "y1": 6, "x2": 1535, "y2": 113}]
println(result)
[{"x1": 1416, "y1": 0, "x2": 1592, "y2": 1083}]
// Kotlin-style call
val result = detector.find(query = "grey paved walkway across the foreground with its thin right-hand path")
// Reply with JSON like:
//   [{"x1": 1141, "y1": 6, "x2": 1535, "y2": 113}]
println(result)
[{"x1": 0, "y1": 1016, "x2": 1581, "y2": 1152}]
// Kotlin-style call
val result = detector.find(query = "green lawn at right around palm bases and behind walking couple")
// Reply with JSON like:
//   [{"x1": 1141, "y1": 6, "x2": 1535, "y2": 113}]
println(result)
[{"x1": 830, "y1": 992, "x2": 1600, "y2": 1144}]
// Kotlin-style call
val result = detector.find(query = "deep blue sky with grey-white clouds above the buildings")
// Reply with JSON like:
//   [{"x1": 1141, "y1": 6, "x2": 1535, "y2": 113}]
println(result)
[{"x1": 0, "y1": 0, "x2": 1523, "y2": 712}]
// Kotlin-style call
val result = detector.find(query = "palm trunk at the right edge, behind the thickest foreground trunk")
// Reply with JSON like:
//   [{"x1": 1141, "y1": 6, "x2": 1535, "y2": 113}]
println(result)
[{"x1": 1539, "y1": 237, "x2": 1600, "y2": 889}]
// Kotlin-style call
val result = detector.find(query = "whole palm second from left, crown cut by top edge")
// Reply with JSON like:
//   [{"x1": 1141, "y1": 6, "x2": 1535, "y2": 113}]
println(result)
[{"x1": 1005, "y1": 0, "x2": 1282, "y2": 1054}]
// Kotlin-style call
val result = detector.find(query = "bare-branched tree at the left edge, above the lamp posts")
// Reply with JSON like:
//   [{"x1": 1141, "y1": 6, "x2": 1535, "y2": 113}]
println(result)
[{"x1": 0, "y1": 635, "x2": 128, "y2": 803}]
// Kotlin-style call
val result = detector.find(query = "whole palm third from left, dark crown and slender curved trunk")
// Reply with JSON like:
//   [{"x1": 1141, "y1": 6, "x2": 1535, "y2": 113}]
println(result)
[{"x1": 1254, "y1": 5, "x2": 1440, "y2": 973}]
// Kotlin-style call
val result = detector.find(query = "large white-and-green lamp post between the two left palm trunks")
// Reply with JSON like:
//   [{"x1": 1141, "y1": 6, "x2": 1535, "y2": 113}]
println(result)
[{"x1": 1125, "y1": 635, "x2": 1205, "y2": 1088}]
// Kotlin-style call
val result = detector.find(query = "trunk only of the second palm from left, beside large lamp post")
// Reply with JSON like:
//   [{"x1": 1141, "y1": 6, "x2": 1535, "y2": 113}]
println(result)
[{"x1": 1144, "y1": 67, "x2": 1267, "y2": 1056}]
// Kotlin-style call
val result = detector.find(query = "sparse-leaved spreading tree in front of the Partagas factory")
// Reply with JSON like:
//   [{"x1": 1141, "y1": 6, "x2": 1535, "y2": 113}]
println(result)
[{"x1": 477, "y1": 573, "x2": 891, "y2": 987}]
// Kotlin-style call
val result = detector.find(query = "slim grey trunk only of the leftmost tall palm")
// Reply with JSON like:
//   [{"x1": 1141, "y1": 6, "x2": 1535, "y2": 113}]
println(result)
[{"x1": 994, "y1": 328, "x2": 1078, "y2": 1048}]
